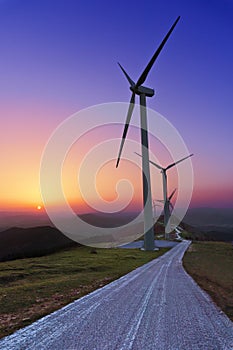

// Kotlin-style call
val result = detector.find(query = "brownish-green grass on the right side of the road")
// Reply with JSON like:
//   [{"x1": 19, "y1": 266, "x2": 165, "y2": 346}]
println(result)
[{"x1": 183, "y1": 242, "x2": 233, "y2": 320}]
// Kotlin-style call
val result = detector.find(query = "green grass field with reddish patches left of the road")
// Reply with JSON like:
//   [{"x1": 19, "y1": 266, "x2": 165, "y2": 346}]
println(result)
[{"x1": 0, "y1": 247, "x2": 167, "y2": 337}]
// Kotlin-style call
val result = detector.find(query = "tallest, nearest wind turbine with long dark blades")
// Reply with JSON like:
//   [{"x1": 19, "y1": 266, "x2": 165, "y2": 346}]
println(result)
[{"x1": 116, "y1": 16, "x2": 180, "y2": 250}]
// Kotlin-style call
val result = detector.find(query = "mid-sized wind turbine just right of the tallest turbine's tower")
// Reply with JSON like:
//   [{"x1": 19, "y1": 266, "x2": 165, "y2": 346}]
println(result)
[{"x1": 135, "y1": 152, "x2": 193, "y2": 239}]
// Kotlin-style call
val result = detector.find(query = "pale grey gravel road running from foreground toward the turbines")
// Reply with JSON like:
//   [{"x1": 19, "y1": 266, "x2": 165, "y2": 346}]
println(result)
[{"x1": 0, "y1": 241, "x2": 233, "y2": 350}]
